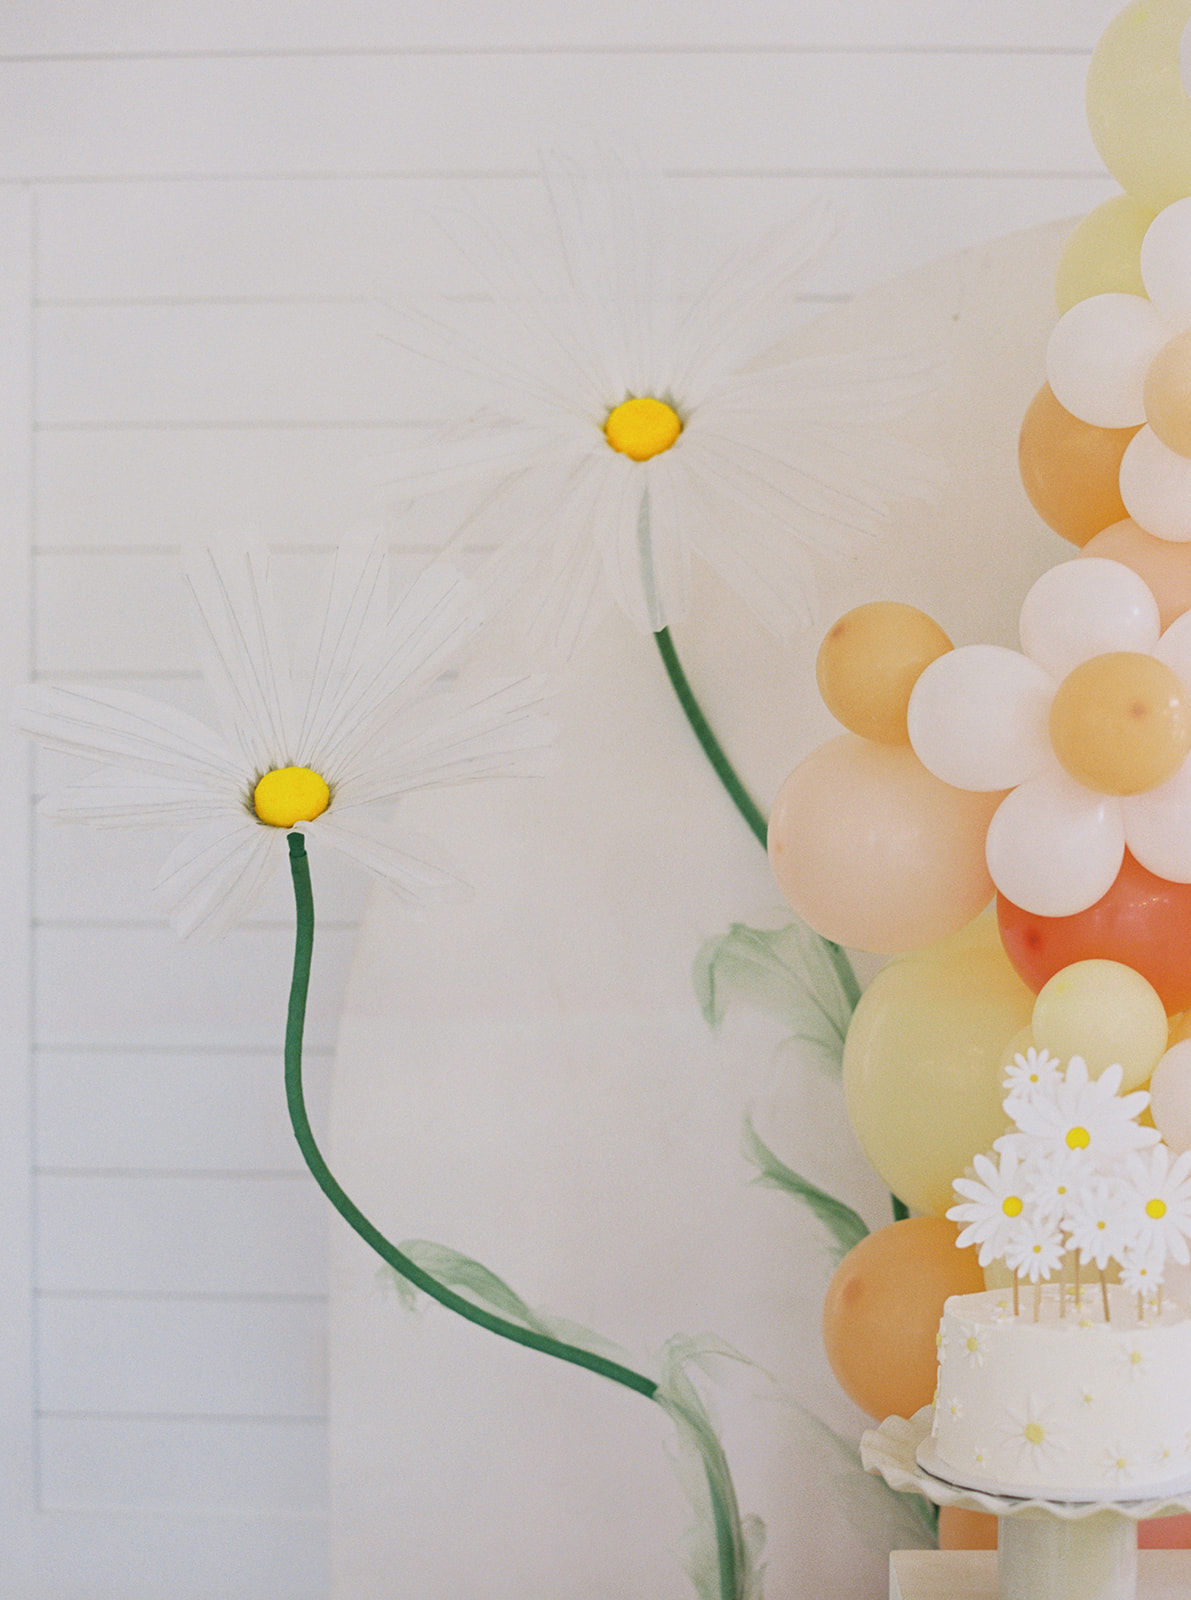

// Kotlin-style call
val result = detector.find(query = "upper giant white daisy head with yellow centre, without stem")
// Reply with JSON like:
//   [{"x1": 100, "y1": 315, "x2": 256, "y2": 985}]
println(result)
[{"x1": 380, "y1": 151, "x2": 936, "y2": 650}]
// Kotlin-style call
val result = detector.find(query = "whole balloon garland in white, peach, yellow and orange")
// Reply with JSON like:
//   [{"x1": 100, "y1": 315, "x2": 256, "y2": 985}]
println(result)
[{"x1": 768, "y1": 0, "x2": 1191, "y2": 1504}]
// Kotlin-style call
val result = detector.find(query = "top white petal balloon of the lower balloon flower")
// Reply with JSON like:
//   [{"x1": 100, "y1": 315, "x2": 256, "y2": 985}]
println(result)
[{"x1": 1020, "y1": 555, "x2": 1162, "y2": 680}]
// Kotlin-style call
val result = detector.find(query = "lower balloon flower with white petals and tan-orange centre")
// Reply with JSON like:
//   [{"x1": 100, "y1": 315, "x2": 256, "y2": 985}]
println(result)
[{"x1": 908, "y1": 557, "x2": 1191, "y2": 917}]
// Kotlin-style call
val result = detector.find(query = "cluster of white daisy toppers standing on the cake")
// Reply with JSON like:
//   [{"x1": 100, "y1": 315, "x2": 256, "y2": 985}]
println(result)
[{"x1": 948, "y1": 1048, "x2": 1191, "y2": 1312}]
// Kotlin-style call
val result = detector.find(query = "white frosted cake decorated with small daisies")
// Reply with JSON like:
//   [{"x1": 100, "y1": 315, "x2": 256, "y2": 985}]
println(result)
[{"x1": 919, "y1": 1285, "x2": 1191, "y2": 1499}]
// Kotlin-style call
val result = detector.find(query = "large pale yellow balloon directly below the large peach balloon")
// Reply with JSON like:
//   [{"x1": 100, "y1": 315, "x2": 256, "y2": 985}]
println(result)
[{"x1": 844, "y1": 915, "x2": 1030, "y2": 1216}]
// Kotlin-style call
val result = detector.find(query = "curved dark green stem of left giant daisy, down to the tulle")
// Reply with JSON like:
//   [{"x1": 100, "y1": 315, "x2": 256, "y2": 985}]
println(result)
[{"x1": 285, "y1": 834, "x2": 658, "y2": 1400}]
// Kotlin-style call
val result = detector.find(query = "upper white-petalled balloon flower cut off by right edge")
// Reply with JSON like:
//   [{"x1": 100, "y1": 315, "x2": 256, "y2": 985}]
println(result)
[{"x1": 1047, "y1": 198, "x2": 1191, "y2": 541}]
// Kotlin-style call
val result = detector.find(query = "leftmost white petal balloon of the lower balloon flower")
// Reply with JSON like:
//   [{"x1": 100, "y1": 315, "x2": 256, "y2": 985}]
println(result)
[{"x1": 906, "y1": 645, "x2": 1055, "y2": 789}]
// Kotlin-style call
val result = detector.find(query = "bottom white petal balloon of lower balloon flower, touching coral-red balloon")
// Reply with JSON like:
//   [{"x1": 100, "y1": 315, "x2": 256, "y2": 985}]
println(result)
[{"x1": 984, "y1": 771, "x2": 1125, "y2": 917}]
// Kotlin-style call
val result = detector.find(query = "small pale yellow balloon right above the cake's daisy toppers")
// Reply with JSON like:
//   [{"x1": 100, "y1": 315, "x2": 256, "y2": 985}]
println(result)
[{"x1": 1033, "y1": 962, "x2": 1167, "y2": 1090}]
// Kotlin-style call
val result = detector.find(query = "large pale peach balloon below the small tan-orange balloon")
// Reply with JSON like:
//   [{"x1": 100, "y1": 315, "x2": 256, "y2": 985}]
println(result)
[{"x1": 768, "y1": 733, "x2": 999, "y2": 954}]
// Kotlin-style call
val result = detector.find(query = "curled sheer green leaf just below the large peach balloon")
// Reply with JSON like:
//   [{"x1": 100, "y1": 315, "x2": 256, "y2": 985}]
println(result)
[{"x1": 693, "y1": 922, "x2": 855, "y2": 1077}]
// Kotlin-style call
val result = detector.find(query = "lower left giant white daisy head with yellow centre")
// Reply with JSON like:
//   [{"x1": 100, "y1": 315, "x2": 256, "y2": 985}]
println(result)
[{"x1": 14, "y1": 538, "x2": 549, "y2": 938}]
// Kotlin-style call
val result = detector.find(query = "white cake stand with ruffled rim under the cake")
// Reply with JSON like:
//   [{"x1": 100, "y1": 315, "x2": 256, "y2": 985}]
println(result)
[{"x1": 860, "y1": 1406, "x2": 1191, "y2": 1600}]
